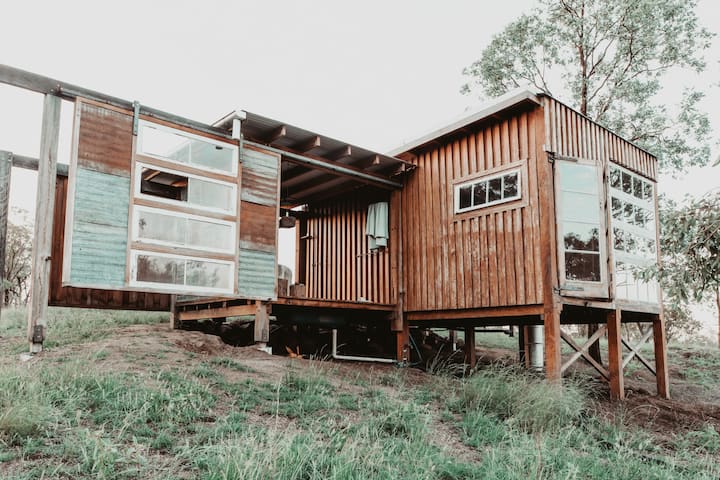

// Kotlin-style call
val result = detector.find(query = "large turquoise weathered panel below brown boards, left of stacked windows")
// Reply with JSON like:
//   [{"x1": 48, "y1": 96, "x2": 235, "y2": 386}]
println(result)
[{"x1": 70, "y1": 168, "x2": 130, "y2": 287}]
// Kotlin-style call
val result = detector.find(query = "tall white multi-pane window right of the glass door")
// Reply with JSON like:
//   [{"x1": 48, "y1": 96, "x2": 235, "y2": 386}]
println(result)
[{"x1": 609, "y1": 165, "x2": 658, "y2": 303}]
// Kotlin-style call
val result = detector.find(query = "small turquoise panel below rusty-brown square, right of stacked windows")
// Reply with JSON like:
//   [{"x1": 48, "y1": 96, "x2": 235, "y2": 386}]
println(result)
[{"x1": 238, "y1": 242, "x2": 277, "y2": 299}]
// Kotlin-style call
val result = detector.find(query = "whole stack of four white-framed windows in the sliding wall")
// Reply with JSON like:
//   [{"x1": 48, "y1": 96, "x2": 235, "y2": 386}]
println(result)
[{"x1": 129, "y1": 121, "x2": 238, "y2": 295}]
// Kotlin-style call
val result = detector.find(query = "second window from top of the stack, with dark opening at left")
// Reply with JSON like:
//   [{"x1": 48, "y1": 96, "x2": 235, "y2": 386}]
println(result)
[{"x1": 135, "y1": 163, "x2": 237, "y2": 214}]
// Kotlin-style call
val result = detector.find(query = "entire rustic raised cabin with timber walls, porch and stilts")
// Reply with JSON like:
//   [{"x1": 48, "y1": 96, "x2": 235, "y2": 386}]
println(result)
[{"x1": 0, "y1": 66, "x2": 669, "y2": 398}]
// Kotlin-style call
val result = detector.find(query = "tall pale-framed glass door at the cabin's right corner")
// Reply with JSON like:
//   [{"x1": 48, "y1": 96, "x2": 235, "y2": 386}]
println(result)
[{"x1": 555, "y1": 160, "x2": 608, "y2": 298}]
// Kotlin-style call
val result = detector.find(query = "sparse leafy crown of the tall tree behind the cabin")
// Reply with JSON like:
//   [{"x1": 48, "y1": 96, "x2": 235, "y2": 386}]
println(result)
[{"x1": 462, "y1": 0, "x2": 713, "y2": 171}]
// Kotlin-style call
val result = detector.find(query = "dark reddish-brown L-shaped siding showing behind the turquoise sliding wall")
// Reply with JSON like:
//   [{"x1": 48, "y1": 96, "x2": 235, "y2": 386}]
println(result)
[{"x1": 49, "y1": 177, "x2": 170, "y2": 311}]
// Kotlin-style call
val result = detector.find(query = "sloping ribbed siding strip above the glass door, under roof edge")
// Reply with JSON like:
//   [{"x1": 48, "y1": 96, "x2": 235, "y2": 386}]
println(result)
[{"x1": 543, "y1": 97, "x2": 657, "y2": 180}]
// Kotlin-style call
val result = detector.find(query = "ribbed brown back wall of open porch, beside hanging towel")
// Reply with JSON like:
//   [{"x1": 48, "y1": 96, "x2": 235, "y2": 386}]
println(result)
[{"x1": 300, "y1": 191, "x2": 395, "y2": 303}]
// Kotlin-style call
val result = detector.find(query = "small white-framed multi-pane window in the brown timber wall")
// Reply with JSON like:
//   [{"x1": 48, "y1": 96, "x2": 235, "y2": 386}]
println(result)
[{"x1": 455, "y1": 170, "x2": 521, "y2": 213}]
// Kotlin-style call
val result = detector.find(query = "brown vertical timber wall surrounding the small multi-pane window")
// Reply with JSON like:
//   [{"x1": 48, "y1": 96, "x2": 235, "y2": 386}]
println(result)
[{"x1": 402, "y1": 108, "x2": 543, "y2": 311}]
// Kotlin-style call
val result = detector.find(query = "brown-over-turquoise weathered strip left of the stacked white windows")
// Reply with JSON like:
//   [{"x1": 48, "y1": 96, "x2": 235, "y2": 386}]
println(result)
[{"x1": 63, "y1": 99, "x2": 133, "y2": 289}]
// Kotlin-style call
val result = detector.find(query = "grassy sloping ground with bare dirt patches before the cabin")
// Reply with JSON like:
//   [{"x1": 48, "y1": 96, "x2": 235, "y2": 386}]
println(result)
[{"x1": 0, "y1": 309, "x2": 720, "y2": 480}]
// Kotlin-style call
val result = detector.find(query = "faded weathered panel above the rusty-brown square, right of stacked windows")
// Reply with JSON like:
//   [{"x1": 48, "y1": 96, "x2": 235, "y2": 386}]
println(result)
[{"x1": 240, "y1": 148, "x2": 279, "y2": 205}]
